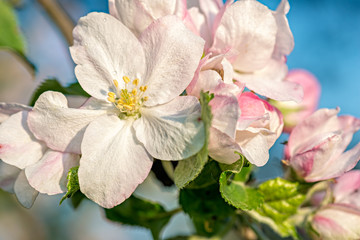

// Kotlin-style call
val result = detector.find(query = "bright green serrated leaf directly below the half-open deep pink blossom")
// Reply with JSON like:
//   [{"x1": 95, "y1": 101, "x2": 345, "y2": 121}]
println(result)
[{"x1": 219, "y1": 155, "x2": 264, "y2": 210}]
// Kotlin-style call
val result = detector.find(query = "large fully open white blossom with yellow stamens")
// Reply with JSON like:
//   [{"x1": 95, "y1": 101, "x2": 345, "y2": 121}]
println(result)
[{"x1": 29, "y1": 13, "x2": 204, "y2": 208}]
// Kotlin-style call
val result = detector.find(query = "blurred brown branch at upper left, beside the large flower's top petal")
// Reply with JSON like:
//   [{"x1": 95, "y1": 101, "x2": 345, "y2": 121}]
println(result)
[{"x1": 38, "y1": 0, "x2": 74, "y2": 46}]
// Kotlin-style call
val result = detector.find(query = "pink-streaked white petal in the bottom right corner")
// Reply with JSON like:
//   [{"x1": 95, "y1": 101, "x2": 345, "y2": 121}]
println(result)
[{"x1": 312, "y1": 204, "x2": 360, "y2": 239}]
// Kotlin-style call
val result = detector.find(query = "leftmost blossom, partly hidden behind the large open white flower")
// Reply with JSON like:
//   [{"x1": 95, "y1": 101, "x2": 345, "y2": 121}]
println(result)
[{"x1": 0, "y1": 106, "x2": 79, "y2": 208}]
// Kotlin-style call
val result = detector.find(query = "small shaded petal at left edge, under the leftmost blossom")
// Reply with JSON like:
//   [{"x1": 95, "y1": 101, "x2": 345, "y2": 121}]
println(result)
[{"x1": 0, "y1": 160, "x2": 21, "y2": 193}]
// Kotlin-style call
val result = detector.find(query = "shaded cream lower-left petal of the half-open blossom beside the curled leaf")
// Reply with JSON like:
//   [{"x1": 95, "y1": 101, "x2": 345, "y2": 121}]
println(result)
[{"x1": 208, "y1": 127, "x2": 242, "y2": 164}]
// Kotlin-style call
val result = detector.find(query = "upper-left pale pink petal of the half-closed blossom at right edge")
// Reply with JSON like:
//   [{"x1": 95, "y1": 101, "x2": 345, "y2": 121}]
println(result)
[{"x1": 288, "y1": 108, "x2": 340, "y2": 156}]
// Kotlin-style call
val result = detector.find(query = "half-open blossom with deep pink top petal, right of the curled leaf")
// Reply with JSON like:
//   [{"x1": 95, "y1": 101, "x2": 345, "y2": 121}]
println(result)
[{"x1": 209, "y1": 92, "x2": 283, "y2": 166}]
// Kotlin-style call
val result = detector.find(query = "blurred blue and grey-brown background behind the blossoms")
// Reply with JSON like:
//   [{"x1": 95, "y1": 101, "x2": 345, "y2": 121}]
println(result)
[{"x1": 0, "y1": 0, "x2": 360, "y2": 240}]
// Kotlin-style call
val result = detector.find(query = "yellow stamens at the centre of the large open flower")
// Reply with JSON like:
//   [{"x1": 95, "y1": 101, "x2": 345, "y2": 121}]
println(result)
[{"x1": 107, "y1": 76, "x2": 148, "y2": 118}]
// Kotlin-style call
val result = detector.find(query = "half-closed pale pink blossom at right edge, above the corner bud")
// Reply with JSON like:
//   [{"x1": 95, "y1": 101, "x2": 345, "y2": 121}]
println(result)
[{"x1": 285, "y1": 109, "x2": 360, "y2": 182}]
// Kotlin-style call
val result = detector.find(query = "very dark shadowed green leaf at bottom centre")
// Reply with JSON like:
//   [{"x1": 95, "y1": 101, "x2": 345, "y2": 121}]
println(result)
[{"x1": 179, "y1": 184, "x2": 235, "y2": 237}]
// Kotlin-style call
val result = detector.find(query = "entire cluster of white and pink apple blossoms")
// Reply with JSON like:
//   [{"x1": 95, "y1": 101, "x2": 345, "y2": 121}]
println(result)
[{"x1": 0, "y1": 0, "x2": 360, "y2": 239}]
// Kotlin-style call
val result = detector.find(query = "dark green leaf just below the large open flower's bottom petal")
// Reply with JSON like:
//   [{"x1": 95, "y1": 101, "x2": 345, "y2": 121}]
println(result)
[{"x1": 105, "y1": 196, "x2": 178, "y2": 239}]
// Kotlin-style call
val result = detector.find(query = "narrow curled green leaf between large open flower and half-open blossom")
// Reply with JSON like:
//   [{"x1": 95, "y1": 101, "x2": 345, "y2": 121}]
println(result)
[{"x1": 174, "y1": 92, "x2": 214, "y2": 189}]
